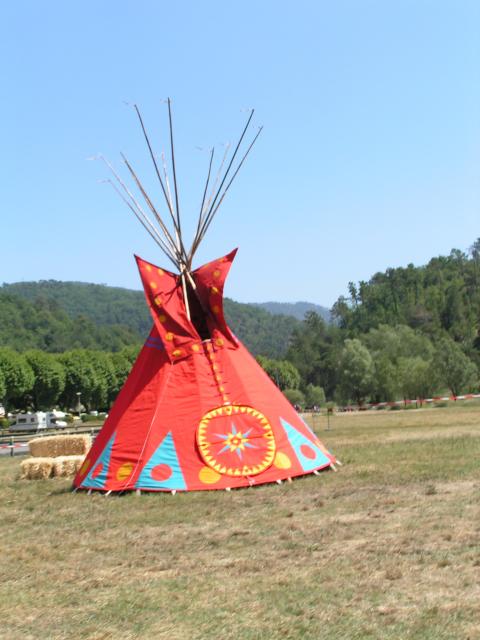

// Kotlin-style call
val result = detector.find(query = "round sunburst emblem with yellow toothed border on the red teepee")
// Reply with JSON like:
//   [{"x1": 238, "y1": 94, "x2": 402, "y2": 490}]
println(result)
[{"x1": 197, "y1": 405, "x2": 276, "y2": 477}]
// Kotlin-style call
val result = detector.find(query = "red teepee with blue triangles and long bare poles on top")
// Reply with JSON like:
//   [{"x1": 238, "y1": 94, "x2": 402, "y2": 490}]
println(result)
[{"x1": 74, "y1": 101, "x2": 335, "y2": 491}]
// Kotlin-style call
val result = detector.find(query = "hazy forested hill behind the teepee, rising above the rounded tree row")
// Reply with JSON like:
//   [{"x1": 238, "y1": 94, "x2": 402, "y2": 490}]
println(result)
[{"x1": 0, "y1": 280, "x2": 299, "y2": 358}]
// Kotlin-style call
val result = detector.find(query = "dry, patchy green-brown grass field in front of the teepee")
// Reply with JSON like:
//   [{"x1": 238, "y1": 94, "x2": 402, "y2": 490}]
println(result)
[{"x1": 0, "y1": 404, "x2": 480, "y2": 640}]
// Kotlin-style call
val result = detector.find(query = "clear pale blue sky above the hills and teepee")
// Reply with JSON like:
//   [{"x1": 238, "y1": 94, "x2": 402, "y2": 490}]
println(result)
[{"x1": 0, "y1": 0, "x2": 480, "y2": 305}]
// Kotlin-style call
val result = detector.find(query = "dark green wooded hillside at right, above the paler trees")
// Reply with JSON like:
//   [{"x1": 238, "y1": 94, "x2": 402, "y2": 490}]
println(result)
[{"x1": 333, "y1": 240, "x2": 480, "y2": 349}]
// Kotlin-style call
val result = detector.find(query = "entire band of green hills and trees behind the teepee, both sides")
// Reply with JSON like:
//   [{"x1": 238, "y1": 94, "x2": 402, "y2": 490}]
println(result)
[{"x1": 0, "y1": 240, "x2": 480, "y2": 408}]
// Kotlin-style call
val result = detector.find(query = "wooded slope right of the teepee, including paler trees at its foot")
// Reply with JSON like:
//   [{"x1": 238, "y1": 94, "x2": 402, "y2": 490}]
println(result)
[{"x1": 287, "y1": 240, "x2": 480, "y2": 403}]
